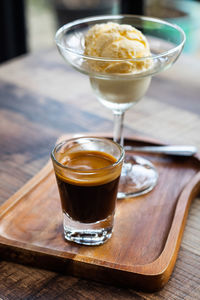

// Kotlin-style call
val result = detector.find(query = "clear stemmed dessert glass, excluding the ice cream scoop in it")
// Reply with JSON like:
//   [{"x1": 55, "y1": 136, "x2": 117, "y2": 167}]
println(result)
[{"x1": 55, "y1": 15, "x2": 185, "y2": 198}]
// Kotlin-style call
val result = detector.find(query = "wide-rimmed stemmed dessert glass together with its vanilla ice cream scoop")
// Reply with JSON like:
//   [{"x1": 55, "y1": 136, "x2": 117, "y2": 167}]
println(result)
[{"x1": 55, "y1": 15, "x2": 185, "y2": 198}]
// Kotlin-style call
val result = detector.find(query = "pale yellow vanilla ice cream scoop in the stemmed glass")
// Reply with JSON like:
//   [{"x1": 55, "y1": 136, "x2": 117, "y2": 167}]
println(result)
[{"x1": 84, "y1": 22, "x2": 151, "y2": 73}]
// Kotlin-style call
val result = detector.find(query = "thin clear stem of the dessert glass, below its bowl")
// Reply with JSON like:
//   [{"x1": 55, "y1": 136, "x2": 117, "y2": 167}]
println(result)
[{"x1": 113, "y1": 110, "x2": 124, "y2": 147}]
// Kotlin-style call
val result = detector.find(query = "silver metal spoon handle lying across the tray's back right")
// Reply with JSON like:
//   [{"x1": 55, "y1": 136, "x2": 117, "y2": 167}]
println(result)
[{"x1": 124, "y1": 145, "x2": 197, "y2": 156}]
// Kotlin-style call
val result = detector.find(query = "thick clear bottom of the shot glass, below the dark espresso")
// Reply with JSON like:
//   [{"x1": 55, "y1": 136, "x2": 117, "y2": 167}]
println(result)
[{"x1": 63, "y1": 213, "x2": 114, "y2": 246}]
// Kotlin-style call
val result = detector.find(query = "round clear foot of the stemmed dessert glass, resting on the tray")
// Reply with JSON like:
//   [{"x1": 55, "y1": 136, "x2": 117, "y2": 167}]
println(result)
[{"x1": 117, "y1": 154, "x2": 158, "y2": 199}]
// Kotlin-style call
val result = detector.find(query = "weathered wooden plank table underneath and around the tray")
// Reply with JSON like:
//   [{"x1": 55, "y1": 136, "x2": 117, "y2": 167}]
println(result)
[{"x1": 0, "y1": 49, "x2": 200, "y2": 300}]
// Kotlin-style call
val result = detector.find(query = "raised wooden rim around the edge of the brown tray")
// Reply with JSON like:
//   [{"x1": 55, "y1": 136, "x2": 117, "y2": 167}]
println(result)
[{"x1": 0, "y1": 133, "x2": 200, "y2": 285}]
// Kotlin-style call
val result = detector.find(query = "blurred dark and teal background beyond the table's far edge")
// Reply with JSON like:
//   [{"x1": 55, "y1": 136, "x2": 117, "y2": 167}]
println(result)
[{"x1": 0, "y1": 0, "x2": 200, "y2": 63}]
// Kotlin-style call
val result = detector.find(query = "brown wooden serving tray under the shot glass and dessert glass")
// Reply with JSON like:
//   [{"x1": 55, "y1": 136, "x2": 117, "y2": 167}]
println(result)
[{"x1": 0, "y1": 136, "x2": 200, "y2": 291}]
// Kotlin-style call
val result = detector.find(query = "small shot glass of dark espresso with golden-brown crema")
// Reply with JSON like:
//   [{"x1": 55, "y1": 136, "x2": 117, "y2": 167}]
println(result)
[{"x1": 51, "y1": 137, "x2": 124, "y2": 245}]
